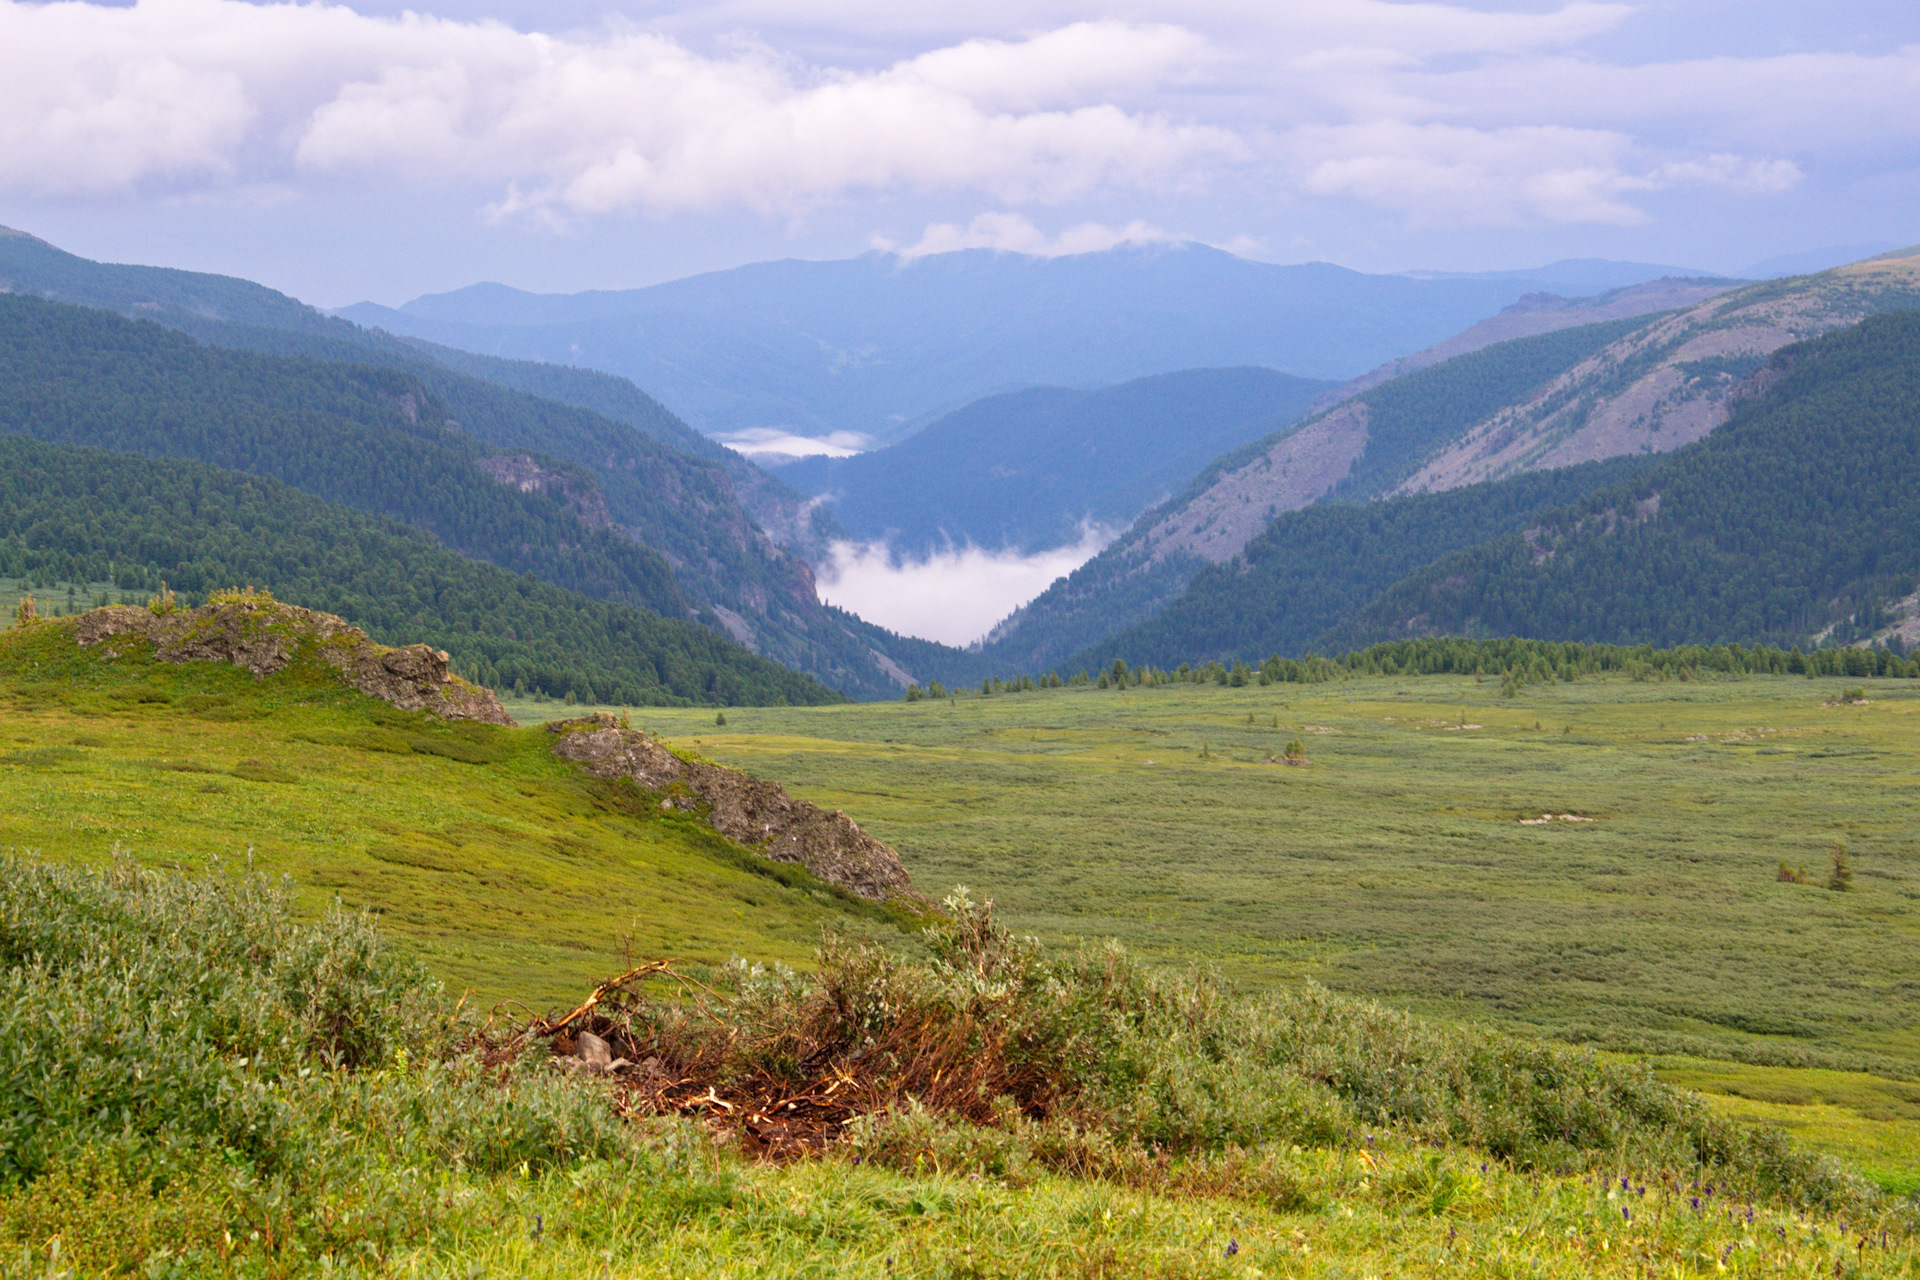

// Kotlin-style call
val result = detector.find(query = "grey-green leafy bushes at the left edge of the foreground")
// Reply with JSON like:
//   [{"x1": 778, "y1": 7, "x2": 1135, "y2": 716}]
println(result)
[{"x1": 0, "y1": 858, "x2": 620, "y2": 1190}]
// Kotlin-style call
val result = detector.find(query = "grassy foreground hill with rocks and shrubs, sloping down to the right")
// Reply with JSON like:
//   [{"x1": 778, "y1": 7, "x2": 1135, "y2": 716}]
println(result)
[{"x1": 0, "y1": 620, "x2": 1916, "y2": 1278}]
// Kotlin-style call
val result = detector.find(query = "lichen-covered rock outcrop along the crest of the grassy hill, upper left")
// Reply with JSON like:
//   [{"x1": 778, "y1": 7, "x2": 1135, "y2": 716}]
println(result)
[{"x1": 73, "y1": 597, "x2": 513, "y2": 725}]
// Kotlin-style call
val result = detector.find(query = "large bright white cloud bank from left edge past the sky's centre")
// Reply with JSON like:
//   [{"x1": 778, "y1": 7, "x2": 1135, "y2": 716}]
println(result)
[{"x1": 0, "y1": 0, "x2": 1244, "y2": 215}]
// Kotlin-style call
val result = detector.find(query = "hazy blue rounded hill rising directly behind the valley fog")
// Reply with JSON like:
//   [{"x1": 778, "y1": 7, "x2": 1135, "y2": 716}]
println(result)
[{"x1": 780, "y1": 368, "x2": 1327, "y2": 555}]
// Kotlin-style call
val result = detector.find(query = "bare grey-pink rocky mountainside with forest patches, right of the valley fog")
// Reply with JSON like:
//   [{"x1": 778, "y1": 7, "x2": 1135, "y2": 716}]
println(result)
[{"x1": 960, "y1": 243, "x2": 1920, "y2": 670}]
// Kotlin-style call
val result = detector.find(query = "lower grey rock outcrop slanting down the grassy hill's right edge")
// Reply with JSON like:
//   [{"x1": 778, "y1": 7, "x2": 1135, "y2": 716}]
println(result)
[{"x1": 547, "y1": 714, "x2": 918, "y2": 902}]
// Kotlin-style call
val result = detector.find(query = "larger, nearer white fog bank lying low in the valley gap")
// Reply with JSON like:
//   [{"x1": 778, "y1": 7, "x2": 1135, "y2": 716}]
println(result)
[{"x1": 818, "y1": 528, "x2": 1116, "y2": 645}]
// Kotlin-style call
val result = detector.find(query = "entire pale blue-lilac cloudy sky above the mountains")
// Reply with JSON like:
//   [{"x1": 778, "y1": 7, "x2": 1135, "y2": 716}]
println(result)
[{"x1": 0, "y1": 0, "x2": 1920, "y2": 305}]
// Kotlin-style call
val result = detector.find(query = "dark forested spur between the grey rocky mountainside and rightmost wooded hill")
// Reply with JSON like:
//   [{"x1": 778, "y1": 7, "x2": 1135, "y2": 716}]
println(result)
[{"x1": 1060, "y1": 457, "x2": 1651, "y2": 674}]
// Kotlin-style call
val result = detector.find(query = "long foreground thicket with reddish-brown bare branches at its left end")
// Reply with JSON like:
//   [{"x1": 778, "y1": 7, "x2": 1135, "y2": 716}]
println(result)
[{"x1": 564, "y1": 890, "x2": 1876, "y2": 1205}]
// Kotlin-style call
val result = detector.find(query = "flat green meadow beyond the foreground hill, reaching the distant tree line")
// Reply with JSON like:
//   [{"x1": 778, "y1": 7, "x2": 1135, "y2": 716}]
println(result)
[{"x1": 564, "y1": 676, "x2": 1920, "y2": 1190}]
